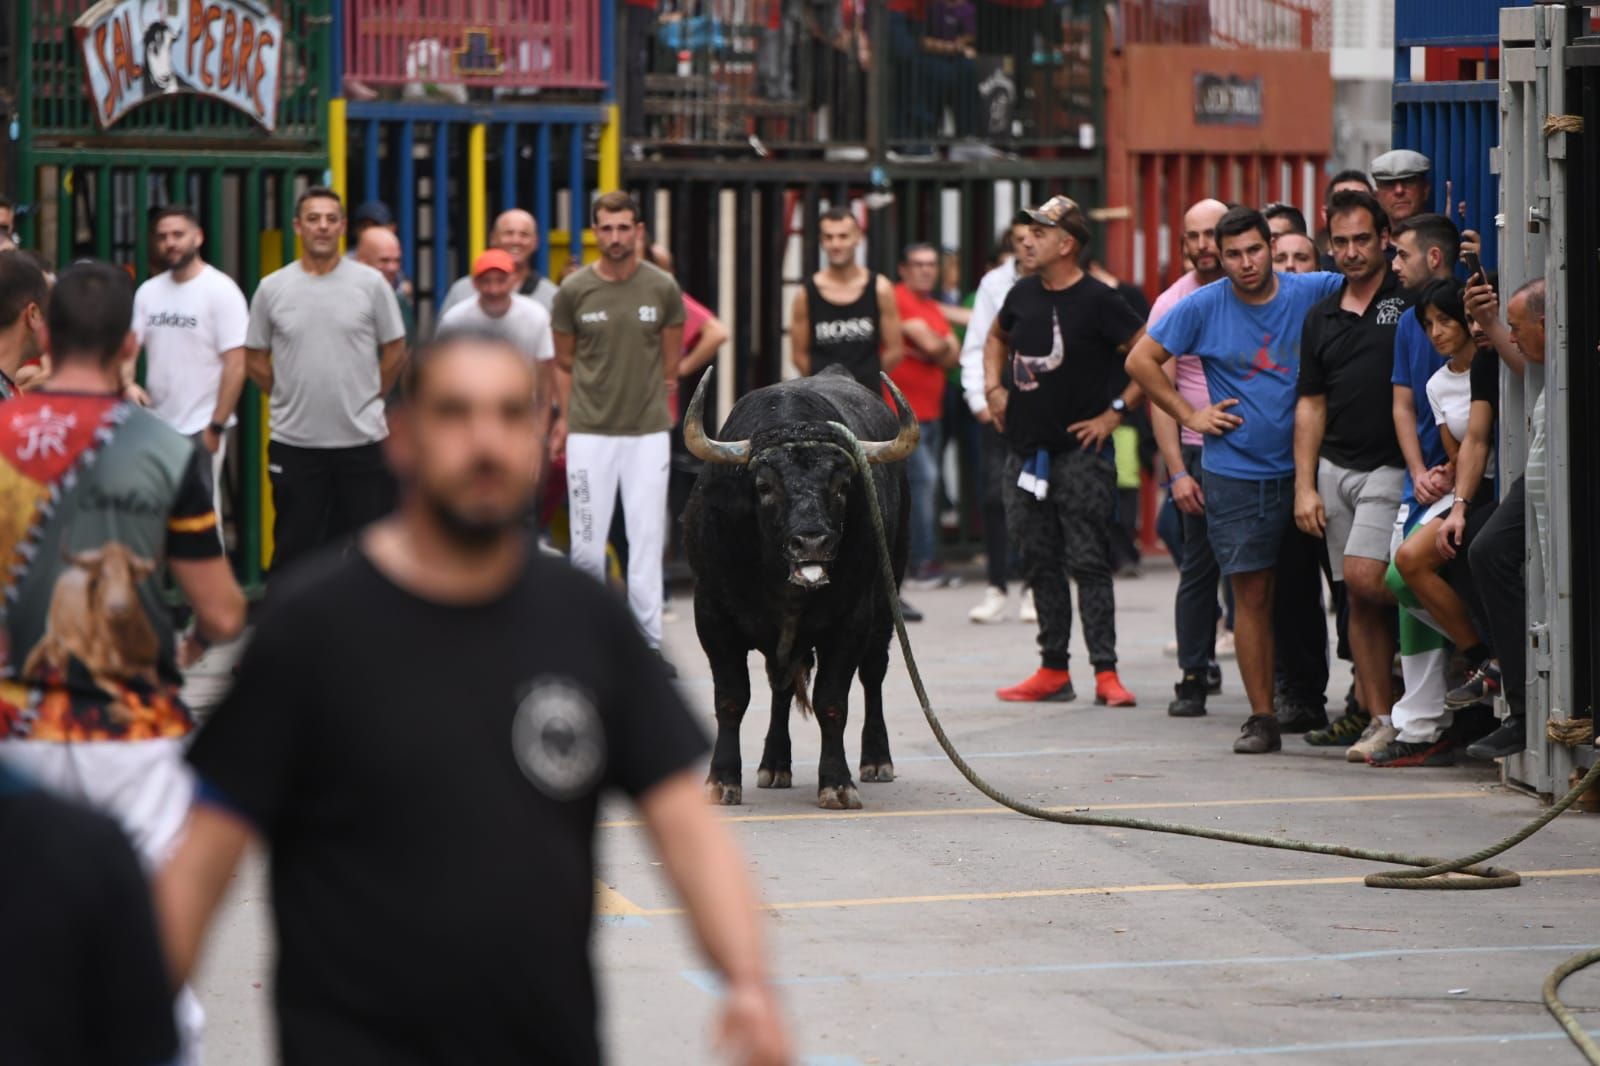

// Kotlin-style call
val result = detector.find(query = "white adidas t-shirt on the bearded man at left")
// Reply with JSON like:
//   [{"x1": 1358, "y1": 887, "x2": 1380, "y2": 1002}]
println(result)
[{"x1": 133, "y1": 264, "x2": 250, "y2": 435}]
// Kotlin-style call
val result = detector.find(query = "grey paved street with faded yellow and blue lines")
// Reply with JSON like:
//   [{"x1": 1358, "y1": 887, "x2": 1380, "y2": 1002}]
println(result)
[{"x1": 198, "y1": 568, "x2": 1600, "y2": 1066}]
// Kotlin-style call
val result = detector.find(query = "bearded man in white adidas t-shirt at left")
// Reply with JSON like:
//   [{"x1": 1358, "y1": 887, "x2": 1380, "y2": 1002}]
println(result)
[{"x1": 133, "y1": 203, "x2": 250, "y2": 514}]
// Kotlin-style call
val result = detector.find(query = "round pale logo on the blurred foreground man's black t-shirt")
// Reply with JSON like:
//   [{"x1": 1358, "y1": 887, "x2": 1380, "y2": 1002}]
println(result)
[{"x1": 510, "y1": 677, "x2": 606, "y2": 800}]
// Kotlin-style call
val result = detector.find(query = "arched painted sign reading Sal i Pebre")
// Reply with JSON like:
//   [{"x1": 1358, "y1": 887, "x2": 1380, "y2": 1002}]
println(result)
[{"x1": 74, "y1": 0, "x2": 283, "y2": 130}]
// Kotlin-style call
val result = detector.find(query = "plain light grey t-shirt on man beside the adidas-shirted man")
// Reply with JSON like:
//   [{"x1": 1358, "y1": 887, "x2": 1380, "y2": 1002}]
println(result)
[{"x1": 245, "y1": 258, "x2": 405, "y2": 448}]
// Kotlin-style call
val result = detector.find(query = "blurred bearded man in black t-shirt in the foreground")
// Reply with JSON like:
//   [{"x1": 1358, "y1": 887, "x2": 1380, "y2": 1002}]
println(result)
[{"x1": 158, "y1": 333, "x2": 789, "y2": 1066}]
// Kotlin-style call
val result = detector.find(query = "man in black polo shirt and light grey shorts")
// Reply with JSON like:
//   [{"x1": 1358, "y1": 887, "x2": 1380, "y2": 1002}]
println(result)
[{"x1": 1294, "y1": 190, "x2": 1411, "y2": 746}]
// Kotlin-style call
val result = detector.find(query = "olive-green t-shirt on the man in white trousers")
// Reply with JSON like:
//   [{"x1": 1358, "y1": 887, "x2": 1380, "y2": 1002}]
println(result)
[{"x1": 550, "y1": 262, "x2": 683, "y2": 437}]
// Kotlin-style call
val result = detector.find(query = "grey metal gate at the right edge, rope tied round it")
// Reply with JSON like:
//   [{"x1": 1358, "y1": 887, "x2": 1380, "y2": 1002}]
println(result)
[{"x1": 1499, "y1": 5, "x2": 1600, "y2": 795}]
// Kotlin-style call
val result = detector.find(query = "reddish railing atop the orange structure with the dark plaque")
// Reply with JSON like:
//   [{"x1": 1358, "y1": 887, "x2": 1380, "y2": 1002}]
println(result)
[{"x1": 1118, "y1": 0, "x2": 1333, "y2": 51}]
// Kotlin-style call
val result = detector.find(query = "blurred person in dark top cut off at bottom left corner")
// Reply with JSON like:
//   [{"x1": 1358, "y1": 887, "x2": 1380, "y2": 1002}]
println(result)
[{"x1": 0, "y1": 762, "x2": 178, "y2": 1066}]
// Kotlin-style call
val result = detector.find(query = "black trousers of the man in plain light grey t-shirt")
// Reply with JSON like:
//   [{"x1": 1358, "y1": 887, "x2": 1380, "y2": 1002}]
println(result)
[{"x1": 267, "y1": 440, "x2": 395, "y2": 570}]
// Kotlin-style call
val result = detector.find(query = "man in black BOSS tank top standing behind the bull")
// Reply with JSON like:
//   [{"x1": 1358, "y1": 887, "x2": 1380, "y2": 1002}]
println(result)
[{"x1": 789, "y1": 206, "x2": 904, "y2": 392}]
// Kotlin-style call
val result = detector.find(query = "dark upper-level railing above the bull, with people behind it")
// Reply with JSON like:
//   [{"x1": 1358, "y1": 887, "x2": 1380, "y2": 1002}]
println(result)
[{"x1": 640, "y1": 0, "x2": 1104, "y2": 155}]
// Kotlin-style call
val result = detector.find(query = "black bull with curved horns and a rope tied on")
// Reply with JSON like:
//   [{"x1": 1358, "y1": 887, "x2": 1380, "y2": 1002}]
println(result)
[{"x1": 683, "y1": 370, "x2": 918, "y2": 810}]
